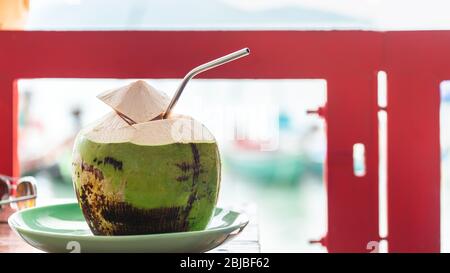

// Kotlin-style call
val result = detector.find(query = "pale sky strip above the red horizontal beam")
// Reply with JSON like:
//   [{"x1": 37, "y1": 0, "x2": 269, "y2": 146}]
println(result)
[{"x1": 27, "y1": 0, "x2": 450, "y2": 30}]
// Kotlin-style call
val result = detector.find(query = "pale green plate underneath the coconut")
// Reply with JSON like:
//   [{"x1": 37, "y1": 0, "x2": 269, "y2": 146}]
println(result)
[{"x1": 8, "y1": 203, "x2": 248, "y2": 253}]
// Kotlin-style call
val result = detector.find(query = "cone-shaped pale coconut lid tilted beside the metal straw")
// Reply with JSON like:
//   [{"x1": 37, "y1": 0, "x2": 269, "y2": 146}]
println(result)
[{"x1": 97, "y1": 80, "x2": 170, "y2": 124}]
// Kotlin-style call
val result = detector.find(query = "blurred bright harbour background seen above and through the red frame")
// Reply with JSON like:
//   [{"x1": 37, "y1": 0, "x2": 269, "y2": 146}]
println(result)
[{"x1": 0, "y1": 0, "x2": 450, "y2": 252}]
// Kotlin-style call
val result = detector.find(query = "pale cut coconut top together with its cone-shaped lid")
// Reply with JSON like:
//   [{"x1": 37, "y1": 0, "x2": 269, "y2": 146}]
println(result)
[{"x1": 80, "y1": 80, "x2": 215, "y2": 146}]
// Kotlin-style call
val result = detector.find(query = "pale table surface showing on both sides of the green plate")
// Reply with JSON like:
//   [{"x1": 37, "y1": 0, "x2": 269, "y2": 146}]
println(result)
[{"x1": 0, "y1": 199, "x2": 260, "y2": 253}]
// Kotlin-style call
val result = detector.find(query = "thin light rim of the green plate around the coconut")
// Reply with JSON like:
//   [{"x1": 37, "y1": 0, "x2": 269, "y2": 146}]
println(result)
[{"x1": 8, "y1": 202, "x2": 250, "y2": 241}]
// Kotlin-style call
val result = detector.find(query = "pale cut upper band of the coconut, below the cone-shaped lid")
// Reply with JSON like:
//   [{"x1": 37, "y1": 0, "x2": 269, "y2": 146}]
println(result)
[{"x1": 80, "y1": 112, "x2": 215, "y2": 146}]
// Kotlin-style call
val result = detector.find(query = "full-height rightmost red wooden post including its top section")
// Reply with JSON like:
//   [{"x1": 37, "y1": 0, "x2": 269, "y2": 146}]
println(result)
[{"x1": 385, "y1": 31, "x2": 450, "y2": 252}]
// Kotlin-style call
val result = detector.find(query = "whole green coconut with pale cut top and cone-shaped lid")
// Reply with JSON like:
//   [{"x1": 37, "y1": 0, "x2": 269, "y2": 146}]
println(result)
[{"x1": 72, "y1": 81, "x2": 220, "y2": 235}]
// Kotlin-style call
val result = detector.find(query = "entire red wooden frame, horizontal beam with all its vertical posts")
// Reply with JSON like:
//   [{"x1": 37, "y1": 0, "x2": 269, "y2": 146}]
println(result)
[{"x1": 0, "y1": 31, "x2": 442, "y2": 252}]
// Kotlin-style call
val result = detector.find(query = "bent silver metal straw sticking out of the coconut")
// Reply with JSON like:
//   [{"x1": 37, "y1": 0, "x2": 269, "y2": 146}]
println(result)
[{"x1": 163, "y1": 48, "x2": 250, "y2": 119}]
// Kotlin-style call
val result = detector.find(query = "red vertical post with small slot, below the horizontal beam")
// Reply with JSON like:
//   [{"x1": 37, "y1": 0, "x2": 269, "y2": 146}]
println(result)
[{"x1": 327, "y1": 71, "x2": 379, "y2": 252}]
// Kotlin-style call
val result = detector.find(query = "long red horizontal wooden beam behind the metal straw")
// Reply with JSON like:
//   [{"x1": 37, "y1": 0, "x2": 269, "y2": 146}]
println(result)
[{"x1": 0, "y1": 31, "x2": 379, "y2": 78}]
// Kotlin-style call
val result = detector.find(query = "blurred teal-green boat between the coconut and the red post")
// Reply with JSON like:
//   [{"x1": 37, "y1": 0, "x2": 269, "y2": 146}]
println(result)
[{"x1": 222, "y1": 116, "x2": 325, "y2": 185}]
